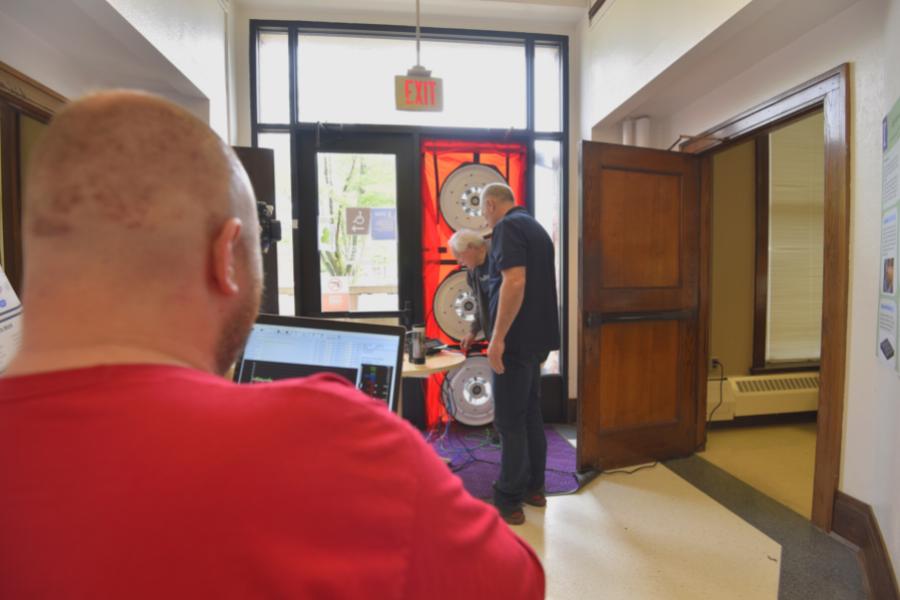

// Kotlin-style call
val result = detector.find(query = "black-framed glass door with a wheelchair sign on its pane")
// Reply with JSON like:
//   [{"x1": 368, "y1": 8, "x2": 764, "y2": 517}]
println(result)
[{"x1": 294, "y1": 134, "x2": 421, "y2": 324}]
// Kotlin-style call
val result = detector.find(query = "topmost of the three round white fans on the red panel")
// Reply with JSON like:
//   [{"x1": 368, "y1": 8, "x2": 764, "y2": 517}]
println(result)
[{"x1": 440, "y1": 164, "x2": 507, "y2": 236}]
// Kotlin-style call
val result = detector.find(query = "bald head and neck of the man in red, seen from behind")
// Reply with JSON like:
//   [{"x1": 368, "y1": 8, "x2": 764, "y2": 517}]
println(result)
[{"x1": 14, "y1": 91, "x2": 260, "y2": 370}]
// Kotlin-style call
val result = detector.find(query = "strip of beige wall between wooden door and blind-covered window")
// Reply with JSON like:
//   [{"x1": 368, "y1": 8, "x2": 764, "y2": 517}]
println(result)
[{"x1": 709, "y1": 141, "x2": 756, "y2": 376}]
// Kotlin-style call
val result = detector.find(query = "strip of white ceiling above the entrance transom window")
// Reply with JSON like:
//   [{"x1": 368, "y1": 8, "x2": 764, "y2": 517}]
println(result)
[{"x1": 231, "y1": 0, "x2": 589, "y2": 26}]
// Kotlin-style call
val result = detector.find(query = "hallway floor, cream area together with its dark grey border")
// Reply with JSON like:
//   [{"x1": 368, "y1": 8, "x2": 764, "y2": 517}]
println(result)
[{"x1": 512, "y1": 426, "x2": 867, "y2": 600}]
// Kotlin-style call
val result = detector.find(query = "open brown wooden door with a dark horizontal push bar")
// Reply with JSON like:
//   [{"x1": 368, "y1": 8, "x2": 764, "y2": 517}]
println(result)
[{"x1": 578, "y1": 142, "x2": 708, "y2": 470}]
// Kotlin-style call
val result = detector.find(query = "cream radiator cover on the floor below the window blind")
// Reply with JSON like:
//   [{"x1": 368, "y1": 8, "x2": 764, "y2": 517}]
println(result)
[{"x1": 706, "y1": 373, "x2": 819, "y2": 421}]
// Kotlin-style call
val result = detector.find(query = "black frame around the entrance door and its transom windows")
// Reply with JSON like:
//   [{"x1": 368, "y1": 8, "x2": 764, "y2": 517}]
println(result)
[{"x1": 249, "y1": 19, "x2": 570, "y2": 410}]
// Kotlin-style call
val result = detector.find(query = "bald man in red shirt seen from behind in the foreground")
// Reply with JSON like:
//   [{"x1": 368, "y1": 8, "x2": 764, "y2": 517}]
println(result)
[{"x1": 0, "y1": 92, "x2": 544, "y2": 600}]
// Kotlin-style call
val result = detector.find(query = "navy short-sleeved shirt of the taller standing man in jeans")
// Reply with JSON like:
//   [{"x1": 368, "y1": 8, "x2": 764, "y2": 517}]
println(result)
[{"x1": 489, "y1": 206, "x2": 559, "y2": 354}]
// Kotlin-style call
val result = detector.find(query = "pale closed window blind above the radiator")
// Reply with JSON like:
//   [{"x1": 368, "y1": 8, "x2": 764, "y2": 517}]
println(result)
[{"x1": 766, "y1": 113, "x2": 825, "y2": 362}]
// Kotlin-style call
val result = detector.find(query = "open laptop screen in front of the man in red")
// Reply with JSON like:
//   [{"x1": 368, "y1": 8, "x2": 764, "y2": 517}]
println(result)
[{"x1": 234, "y1": 315, "x2": 406, "y2": 412}]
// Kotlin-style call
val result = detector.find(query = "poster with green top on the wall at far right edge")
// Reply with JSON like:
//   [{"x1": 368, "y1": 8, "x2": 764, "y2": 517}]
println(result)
[{"x1": 875, "y1": 99, "x2": 900, "y2": 372}]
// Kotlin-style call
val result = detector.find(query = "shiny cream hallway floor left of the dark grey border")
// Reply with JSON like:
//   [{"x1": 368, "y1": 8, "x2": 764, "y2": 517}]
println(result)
[{"x1": 513, "y1": 465, "x2": 781, "y2": 600}]
